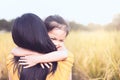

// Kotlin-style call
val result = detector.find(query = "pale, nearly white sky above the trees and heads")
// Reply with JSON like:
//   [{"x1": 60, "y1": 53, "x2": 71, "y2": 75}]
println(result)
[{"x1": 0, "y1": 0, "x2": 120, "y2": 25}]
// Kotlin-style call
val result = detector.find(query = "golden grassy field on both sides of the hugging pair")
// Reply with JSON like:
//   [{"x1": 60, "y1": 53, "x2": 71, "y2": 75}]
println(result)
[{"x1": 0, "y1": 31, "x2": 120, "y2": 80}]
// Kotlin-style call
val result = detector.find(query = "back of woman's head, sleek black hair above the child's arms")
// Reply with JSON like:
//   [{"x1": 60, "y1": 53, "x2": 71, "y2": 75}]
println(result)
[{"x1": 12, "y1": 13, "x2": 56, "y2": 52}]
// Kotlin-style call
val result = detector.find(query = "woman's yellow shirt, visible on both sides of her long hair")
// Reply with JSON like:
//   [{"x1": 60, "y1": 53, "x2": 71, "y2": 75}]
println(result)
[{"x1": 7, "y1": 52, "x2": 74, "y2": 80}]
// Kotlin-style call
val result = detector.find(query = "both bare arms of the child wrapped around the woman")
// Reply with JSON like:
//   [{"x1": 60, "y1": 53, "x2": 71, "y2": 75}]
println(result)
[{"x1": 12, "y1": 46, "x2": 68, "y2": 68}]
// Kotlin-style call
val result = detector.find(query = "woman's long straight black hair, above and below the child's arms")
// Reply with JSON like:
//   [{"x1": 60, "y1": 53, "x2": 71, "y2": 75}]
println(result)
[{"x1": 12, "y1": 13, "x2": 57, "y2": 80}]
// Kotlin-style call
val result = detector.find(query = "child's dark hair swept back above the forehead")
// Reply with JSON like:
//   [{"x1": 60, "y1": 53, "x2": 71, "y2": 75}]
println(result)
[{"x1": 44, "y1": 15, "x2": 70, "y2": 36}]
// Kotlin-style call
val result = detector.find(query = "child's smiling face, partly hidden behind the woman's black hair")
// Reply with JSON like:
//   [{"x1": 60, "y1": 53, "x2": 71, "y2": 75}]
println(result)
[{"x1": 48, "y1": 28, "x2": 66, "y2": 50}]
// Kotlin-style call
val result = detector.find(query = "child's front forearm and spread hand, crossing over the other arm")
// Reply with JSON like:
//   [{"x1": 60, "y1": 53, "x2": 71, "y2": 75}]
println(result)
[{"x1": 19, "y1": 51, "x2": 67, "y2": 68}]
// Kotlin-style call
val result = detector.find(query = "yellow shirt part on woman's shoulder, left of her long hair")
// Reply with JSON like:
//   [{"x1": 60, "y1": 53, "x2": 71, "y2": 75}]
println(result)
[{"x1": 6, "y1": 54, "x2": 19, "y2": 80}]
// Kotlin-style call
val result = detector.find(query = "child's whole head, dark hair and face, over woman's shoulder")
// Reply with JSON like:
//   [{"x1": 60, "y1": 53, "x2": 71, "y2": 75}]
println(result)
[{"x1": 44, "y1": 15, "x2": 70, "y2": 50}]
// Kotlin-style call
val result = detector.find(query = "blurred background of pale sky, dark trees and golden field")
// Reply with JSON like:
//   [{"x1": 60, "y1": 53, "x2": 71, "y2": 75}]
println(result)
[{"x1": 0, "y1": 0, "x2": 120, "y2": 80}]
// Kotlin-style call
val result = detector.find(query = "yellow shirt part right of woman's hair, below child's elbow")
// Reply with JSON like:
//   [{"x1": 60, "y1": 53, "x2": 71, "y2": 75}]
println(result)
[{"x1": 47, "y1": 53, "x2": 74, "y2": 80}]
